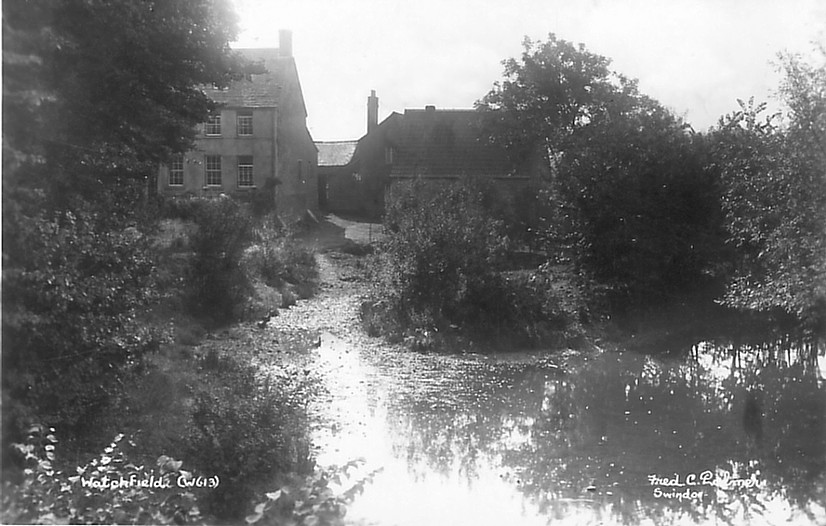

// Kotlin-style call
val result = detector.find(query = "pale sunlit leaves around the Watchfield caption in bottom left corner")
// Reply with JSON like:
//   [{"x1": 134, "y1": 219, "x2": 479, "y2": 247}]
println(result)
[{"x1": 2, "y1": 426, "x2": 203, "y2": 524}]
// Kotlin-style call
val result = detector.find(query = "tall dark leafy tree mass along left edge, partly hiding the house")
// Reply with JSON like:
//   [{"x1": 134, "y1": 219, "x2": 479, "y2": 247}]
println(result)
[{"x1": 3, "y1": 0, "x2": 237, "y2": 442}]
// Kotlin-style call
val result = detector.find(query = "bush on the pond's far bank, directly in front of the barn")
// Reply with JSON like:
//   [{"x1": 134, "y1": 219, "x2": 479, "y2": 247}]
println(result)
[{"x1": 368, "y1": 181, "x2": 585, "y2": 349}]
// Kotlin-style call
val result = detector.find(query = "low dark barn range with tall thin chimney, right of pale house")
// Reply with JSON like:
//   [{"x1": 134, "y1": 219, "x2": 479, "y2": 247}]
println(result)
[{"x1": 316, "y1": 91, "x2": 544, "y2": 217}]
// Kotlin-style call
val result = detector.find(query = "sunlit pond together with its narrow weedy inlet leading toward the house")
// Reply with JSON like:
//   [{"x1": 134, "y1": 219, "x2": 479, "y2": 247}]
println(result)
[{"x1": 253, "y1": 220, "x2": 826, "y2": 526}]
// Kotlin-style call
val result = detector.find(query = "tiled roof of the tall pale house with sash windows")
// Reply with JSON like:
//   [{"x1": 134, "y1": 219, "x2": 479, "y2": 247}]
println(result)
[{"x1": 204, "y1": 48, "x2": 293, "y2": 108}]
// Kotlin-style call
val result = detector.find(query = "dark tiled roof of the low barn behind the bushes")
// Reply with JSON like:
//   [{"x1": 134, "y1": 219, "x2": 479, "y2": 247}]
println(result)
[{"x1": 388, "y1": 108, "x2": 514, "y2": 177}]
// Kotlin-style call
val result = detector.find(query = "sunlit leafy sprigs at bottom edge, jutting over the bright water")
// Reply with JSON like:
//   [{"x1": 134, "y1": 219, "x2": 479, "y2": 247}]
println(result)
[{"x1": 246, "y1": 460, "x2": 377, "y2": 526}]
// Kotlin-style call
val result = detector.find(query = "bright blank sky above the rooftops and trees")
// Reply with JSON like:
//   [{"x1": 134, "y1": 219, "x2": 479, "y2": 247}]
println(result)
[{"x1": 233, "y1": 0, "x2": 826, "y2": 141}]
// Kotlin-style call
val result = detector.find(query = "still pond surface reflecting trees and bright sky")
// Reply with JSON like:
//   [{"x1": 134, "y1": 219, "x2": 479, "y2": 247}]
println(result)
[{"x1": 310, "y1": 336, "x2": 826, "y2": 524}]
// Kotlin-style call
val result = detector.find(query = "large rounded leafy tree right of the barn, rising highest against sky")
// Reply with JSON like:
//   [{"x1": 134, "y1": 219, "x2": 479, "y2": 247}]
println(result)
[{"x1": 477, "y1": 34, "x2": 721, "y2": 307}]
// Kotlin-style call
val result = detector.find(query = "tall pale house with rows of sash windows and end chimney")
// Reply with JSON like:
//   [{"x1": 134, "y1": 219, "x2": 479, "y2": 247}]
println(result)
[{"x1": 158, "y1": 30, "x2": 319, "y2": 221}]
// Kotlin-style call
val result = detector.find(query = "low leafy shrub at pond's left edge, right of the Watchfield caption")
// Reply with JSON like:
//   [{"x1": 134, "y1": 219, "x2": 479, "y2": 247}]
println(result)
[{"x1": 186, "y1": 350, "x2": 314, "y2": 518}]
